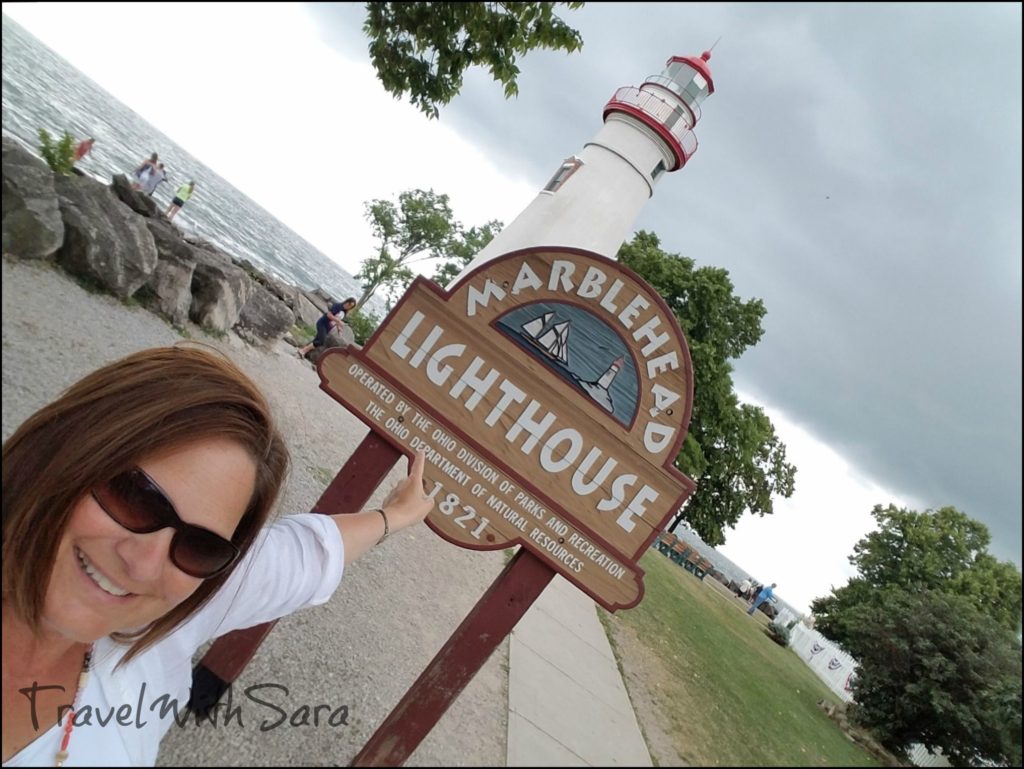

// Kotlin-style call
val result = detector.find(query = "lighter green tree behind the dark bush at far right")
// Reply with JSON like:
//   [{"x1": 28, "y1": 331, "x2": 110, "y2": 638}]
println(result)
[{"x1": 811, "y1": 505, "x2": 1021, "y2": 656}]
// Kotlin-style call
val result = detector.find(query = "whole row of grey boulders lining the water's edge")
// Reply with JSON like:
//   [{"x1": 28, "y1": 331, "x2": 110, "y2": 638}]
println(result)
[{"x1": 3, "y1": 136, "x2": 352, "y2": 346}]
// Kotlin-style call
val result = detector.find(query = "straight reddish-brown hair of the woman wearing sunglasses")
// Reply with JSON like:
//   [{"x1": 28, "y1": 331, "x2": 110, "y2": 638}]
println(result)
[{"x1": 2, "y1": 345, "x2": 289, "y2": 660}]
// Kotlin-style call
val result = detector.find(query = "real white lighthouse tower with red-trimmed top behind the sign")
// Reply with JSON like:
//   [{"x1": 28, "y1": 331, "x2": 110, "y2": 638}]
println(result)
[{"x1": 460, "y1": 51, "x2": 715, "y2": 276}]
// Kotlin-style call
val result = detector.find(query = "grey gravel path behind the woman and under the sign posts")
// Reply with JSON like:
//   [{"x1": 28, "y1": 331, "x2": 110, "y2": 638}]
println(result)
[{"x1": 2, "y1": 257, "x2": 508, "y2": 766}]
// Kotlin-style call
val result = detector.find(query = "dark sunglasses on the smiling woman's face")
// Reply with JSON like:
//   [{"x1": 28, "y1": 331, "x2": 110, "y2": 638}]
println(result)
[{"x1": 91, "y1": 467, "x2": 239, "y2": 580}]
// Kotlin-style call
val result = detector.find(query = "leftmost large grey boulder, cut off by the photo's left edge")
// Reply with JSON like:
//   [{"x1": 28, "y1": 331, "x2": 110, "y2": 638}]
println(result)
[{"x1": 3, "y1": 136, "x2": 65, "y2": 259}]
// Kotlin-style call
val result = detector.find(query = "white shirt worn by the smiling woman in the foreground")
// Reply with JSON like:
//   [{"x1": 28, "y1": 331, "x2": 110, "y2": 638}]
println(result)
[{"x1": 3, "y1": 513, "x2": 345, "y2": 767}]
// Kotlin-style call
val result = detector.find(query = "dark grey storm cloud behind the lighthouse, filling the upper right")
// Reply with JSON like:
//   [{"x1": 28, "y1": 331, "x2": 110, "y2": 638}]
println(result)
[{"x1": 311, "y1": 3, "x2": 1022, "y2": 565}]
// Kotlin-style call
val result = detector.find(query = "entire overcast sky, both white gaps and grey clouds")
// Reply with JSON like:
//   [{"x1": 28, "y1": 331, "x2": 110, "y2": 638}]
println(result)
[{"x1": 4, "y1": 3, "x2": 1022, "y2": 607}]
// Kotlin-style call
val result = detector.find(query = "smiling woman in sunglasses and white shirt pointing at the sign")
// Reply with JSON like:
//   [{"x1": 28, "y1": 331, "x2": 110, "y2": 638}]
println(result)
[{"x1": 2, "y1": 346, "x2": 433, "y2": 766}]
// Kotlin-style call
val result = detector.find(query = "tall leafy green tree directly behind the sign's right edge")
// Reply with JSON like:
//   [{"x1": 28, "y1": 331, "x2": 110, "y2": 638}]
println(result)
[{"x1": 618, "y1": 231, "x2": 797, "y2": 545}]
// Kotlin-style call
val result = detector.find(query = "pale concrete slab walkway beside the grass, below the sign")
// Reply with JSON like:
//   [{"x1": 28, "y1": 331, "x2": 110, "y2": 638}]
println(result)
[{"x1": 507, "y1": 576, "x2": 651, "y2": 766}]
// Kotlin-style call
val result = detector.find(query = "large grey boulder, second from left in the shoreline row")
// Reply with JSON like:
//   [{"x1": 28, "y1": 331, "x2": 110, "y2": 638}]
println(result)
[{"x1": 54, "y1": 175, "x2": 157, "y2": 298}]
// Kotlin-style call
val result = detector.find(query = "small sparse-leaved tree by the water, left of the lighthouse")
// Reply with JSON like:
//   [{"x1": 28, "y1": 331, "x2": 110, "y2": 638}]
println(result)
[{"x1": 355, "y1": 189, "x2": 457, "y2": 307}]
